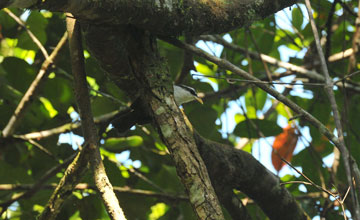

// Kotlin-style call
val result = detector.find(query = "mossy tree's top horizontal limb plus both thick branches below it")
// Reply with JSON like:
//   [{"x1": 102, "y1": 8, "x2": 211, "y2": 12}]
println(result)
[{"x1": 0, "y1": 0, "x2": 306, "y2": 219}]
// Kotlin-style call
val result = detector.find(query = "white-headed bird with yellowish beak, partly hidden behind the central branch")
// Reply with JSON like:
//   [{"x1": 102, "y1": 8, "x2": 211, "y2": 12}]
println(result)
[{"x1": 111, "y1": 84, "x2": 203, "y2": 133}]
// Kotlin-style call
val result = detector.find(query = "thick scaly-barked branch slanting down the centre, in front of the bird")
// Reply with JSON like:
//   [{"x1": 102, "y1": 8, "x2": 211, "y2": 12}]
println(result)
[{"x1": 121, "y1": 28, "x2": 224, "y2": 220}]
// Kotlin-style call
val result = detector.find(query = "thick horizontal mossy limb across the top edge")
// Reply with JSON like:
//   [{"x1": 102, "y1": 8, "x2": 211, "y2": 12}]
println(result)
[{"x1": 6, "y1": 0, "x2": 297, "y2": 36}]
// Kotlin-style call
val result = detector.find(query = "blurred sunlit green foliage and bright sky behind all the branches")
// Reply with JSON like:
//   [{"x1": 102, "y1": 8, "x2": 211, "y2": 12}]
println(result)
[{"x1": 0, "y1": 0, "x2": 360, "y2": 220}]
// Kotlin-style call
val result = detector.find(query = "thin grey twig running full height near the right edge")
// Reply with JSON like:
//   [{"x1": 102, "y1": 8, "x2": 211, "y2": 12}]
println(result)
[{"x1": 305, "y1": 0, "x2": 360, "y2": 220}]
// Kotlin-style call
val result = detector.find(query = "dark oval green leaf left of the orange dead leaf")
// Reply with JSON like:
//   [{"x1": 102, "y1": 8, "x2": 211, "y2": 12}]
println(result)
[{"x1": 234, "y1": 119, "x2": 283, "y2": 138}]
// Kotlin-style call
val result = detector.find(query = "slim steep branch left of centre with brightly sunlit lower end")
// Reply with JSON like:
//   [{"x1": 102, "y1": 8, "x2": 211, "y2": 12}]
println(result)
[{"x1": 66, "y1": 15, "x2": 126, "y2": 219}]
